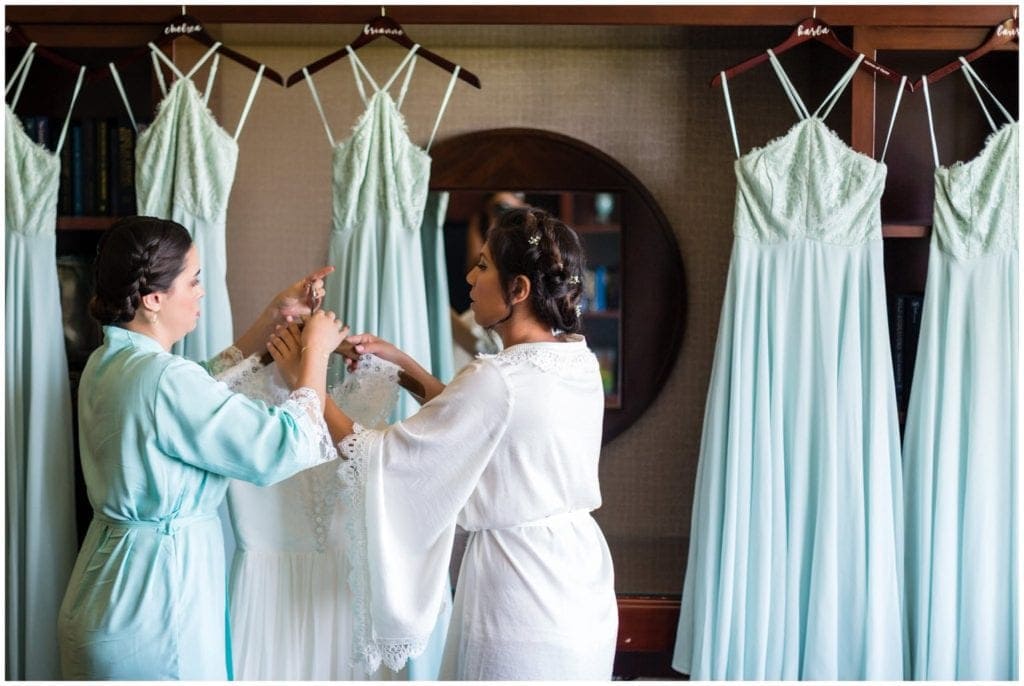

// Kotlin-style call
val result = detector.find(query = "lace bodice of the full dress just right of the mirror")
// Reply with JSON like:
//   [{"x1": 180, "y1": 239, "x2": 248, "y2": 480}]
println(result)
[{"x1": 734, "y1": 117, "x2": 886, "y2": 246}]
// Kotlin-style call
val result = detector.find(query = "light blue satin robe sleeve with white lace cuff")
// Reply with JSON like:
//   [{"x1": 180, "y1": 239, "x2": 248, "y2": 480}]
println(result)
[{"x1": 153, "y1": 358, "x2": 337, "y2": 485}]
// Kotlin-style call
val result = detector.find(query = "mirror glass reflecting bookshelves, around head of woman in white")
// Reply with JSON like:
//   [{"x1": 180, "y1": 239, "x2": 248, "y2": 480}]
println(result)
[{"x1": 444, "y1": 190, "x2": 623, "y2": 408}]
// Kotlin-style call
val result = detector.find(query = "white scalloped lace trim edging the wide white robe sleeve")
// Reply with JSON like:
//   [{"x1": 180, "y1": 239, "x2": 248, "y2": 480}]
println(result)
[{"x1": 338, "y1": 422, "x2": 430, "y2": 674}]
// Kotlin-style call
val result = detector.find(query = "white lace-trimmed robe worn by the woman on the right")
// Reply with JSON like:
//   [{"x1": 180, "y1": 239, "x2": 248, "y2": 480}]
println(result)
[{"x1": 339, "y1": 336, "x2": 617, "y2": 680}]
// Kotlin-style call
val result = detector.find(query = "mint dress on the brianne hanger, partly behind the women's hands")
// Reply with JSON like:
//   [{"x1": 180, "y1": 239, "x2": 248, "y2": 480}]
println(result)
[{"x1": 306, "y1": 45, "x2": 460, "y2": 421}]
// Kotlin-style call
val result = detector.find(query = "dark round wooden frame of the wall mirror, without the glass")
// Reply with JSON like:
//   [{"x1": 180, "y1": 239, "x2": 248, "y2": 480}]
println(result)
[{"x1": 430, "y1": 128, "x2": 686, "y2": 443}]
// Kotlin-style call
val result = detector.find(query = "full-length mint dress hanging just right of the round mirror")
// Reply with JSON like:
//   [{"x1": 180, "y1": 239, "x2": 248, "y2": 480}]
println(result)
[{"x1": 673, "y1": 51, "x2": 903, "y2": 681}]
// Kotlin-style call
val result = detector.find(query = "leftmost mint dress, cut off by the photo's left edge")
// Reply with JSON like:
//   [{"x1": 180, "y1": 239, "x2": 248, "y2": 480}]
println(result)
[{"x1": 4, "y1": 43, "x2": 85, "y2": 681}]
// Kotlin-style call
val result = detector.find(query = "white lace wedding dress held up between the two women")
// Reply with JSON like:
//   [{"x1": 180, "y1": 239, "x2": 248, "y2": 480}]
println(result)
[{"x1": 218, "y1": 355, "x2": 406, "y2": 681}]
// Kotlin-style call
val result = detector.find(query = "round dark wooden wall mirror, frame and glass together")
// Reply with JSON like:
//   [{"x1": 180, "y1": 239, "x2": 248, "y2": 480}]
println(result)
[{"x1": 430, "y1": 128, "x2": 686, "y2": 443}]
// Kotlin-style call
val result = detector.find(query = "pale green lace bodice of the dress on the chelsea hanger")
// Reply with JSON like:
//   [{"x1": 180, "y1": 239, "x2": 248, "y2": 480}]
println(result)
[{"x1": 135, "y1": 78, "x2": 239, "y2": 221}]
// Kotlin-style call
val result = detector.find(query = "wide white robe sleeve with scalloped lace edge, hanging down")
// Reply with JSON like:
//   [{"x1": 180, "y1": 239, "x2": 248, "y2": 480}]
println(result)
[{"x1": 338, "y1": 359, "x2": 513, "y2": 673}]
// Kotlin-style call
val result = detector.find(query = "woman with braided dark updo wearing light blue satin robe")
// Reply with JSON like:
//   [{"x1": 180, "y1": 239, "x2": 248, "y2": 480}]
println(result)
[{"x1": 58, "y1": 217, "x2": 342, "y2": 680}]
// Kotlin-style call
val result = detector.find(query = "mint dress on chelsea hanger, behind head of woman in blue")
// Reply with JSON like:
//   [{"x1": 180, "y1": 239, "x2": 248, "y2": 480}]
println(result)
[{"x1": 111, "y1": 43, "x2": 264, "y2": 361}]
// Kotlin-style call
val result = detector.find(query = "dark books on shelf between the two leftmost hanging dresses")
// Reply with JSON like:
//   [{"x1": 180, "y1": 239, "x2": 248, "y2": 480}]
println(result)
[{"x1": 22, "y1": 117, "x2": 135, "y2": 216}]
